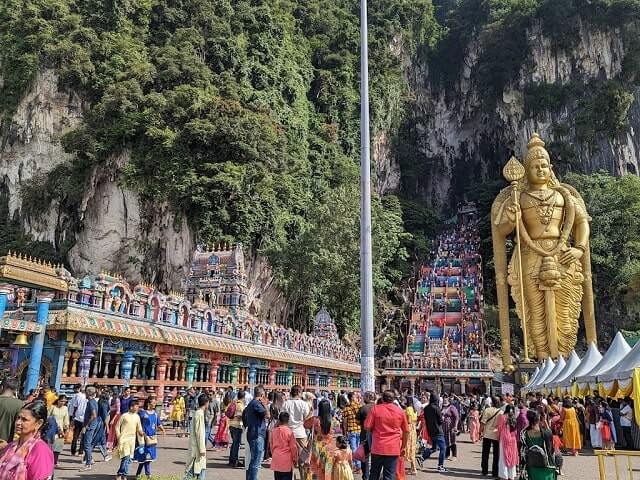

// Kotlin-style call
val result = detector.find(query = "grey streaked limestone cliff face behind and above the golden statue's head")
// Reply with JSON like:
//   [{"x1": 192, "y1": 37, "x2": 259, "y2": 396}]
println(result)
[{"x1": 400, "y1": 18, "x2": 640, "y2": 209}]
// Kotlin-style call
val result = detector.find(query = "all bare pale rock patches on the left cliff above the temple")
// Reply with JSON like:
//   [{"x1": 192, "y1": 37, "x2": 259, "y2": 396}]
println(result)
[{"x1": 0, "y1": 70, "x2": 286, "y2": 306}]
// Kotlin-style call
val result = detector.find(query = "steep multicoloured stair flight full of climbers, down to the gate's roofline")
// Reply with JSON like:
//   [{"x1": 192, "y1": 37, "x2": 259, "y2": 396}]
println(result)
[{"x1": 387, "y1": 214, "x2": 487, "y2": 369}]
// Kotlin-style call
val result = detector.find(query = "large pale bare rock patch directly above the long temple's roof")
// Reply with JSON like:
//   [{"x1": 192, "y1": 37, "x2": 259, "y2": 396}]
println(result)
[{"x1": 68, "y1": 152, "x2": 195, "y2": 290}]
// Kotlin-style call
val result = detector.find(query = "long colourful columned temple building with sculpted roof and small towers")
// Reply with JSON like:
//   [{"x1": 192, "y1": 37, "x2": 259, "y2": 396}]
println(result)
[{"x1": 0, "y1": 244, "x2": 360, "y2": 399}]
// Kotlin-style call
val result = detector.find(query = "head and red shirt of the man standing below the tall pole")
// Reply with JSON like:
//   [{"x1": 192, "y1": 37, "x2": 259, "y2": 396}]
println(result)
[{"x1": 364, "y1": 390, "x2": 409, "y2": 457}]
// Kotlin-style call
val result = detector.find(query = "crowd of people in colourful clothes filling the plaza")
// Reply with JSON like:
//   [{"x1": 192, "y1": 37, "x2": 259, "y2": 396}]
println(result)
[{"x1": 0, "y1": 379, "x2": 638, "y2": 480}]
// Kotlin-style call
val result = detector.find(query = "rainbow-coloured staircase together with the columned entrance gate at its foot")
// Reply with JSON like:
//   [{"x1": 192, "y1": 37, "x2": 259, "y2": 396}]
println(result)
[{"x1": 379, "y1": 204, "x2": 493, "y2": 393}]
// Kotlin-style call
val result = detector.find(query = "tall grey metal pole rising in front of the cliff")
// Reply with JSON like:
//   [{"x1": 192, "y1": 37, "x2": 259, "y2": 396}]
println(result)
[{"x1": 360, "y1": 0, "x2": 375, "y2": 392}]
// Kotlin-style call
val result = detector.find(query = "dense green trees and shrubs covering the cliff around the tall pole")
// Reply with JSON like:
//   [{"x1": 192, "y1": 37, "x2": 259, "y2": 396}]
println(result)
[{"x1": 0, "y1": 0, "x2": 438, "y2": 338}]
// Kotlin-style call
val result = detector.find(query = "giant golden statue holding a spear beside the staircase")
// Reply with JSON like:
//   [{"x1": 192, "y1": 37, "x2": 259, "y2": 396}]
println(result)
[{"x1": 491, "y1": 133, "x2": 596, "y2": 370}]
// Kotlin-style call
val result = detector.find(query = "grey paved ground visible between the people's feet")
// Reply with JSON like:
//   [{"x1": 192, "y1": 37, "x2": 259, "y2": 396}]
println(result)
[{"x1": 55, "y1": 432, "x2": 640, "y2": 480}]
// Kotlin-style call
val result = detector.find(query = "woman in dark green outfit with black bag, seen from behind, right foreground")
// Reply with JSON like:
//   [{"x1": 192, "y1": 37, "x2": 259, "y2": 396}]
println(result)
[{"x1": 520, "y1": 410, "x2": 558, "y2": 480}]
